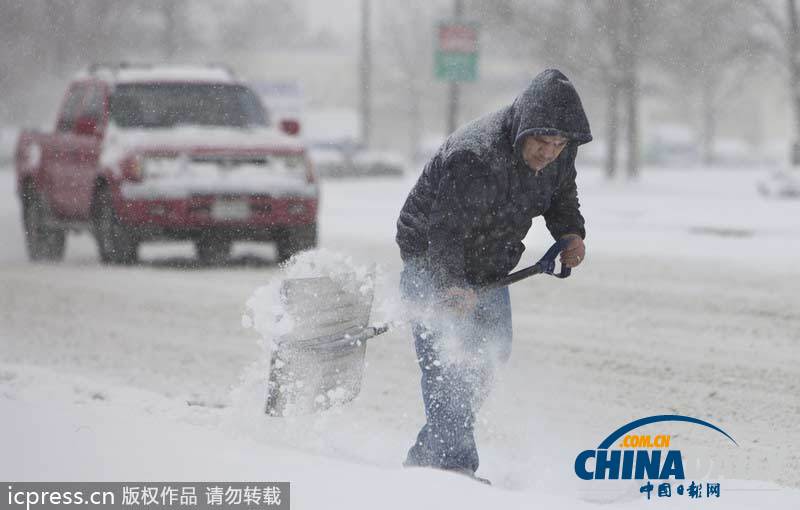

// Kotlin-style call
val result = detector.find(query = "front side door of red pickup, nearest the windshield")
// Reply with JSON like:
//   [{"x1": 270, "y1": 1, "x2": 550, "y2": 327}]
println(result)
[{"x1": 70, "y1": 82, "x2": 107, "y2": 219}]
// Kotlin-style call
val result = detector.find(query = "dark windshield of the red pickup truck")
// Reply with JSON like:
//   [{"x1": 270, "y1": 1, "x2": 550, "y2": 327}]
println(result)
[{"x1": 109, "y1": 83, "x2": 267, "y2": 128}]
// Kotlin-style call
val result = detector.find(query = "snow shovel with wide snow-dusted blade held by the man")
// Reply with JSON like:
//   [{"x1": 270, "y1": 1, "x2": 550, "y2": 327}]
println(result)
[{"x1": 265, "y1": 240, "x2": 570, "y2": 416}]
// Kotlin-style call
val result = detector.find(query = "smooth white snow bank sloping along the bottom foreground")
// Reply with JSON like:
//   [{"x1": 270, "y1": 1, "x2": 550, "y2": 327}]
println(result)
[{"x1": 0, "y1": 364, "x2": 800, "y2": 510}]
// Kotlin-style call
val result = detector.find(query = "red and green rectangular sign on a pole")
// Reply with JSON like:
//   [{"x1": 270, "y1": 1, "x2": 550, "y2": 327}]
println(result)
[{"x1": 434, "y1": 21, "x2": 478, "y2": 81}]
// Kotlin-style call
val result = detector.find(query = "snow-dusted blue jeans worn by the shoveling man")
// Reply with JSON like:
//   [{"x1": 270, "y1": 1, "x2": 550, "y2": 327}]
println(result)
[{"x1": 400, "y1": 260, "x2": 511, "y2": 473}]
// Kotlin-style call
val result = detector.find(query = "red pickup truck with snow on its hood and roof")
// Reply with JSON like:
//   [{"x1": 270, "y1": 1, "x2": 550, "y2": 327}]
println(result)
[{"x1": 16, "y1": 66, "x2": 319, "y2": 264}]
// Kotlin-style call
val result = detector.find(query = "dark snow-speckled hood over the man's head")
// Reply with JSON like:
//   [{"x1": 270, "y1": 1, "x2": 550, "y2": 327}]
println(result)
[{"x1": 511, "y1": 69, "x2": 592, "y2": 153}]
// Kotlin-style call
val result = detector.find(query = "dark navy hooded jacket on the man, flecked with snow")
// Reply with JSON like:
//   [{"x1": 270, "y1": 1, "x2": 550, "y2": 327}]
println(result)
[{"x1": 396, "y1": 69, "x2": 592, "y2": 287}]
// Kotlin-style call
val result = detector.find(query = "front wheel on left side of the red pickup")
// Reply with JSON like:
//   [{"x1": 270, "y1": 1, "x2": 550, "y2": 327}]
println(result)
[{"x1": 92, "y1": 190, "x2": 139, "y2": 264}]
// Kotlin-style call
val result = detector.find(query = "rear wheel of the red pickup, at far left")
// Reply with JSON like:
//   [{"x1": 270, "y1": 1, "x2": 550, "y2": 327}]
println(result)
[{"x1": 22, "y1": 189, "x2": 67, "y2": 261}]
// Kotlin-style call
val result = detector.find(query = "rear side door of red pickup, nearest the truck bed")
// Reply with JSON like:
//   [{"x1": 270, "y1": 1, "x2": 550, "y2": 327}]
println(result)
[{"x1": 42, "y1": 84, "x2": 86, "y2": 217}]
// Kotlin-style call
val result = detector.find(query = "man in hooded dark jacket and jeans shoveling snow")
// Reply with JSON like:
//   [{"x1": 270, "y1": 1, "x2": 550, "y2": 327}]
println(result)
[{"x1": 397, "y1": 69, "x2": 592, "y2": 484}]
